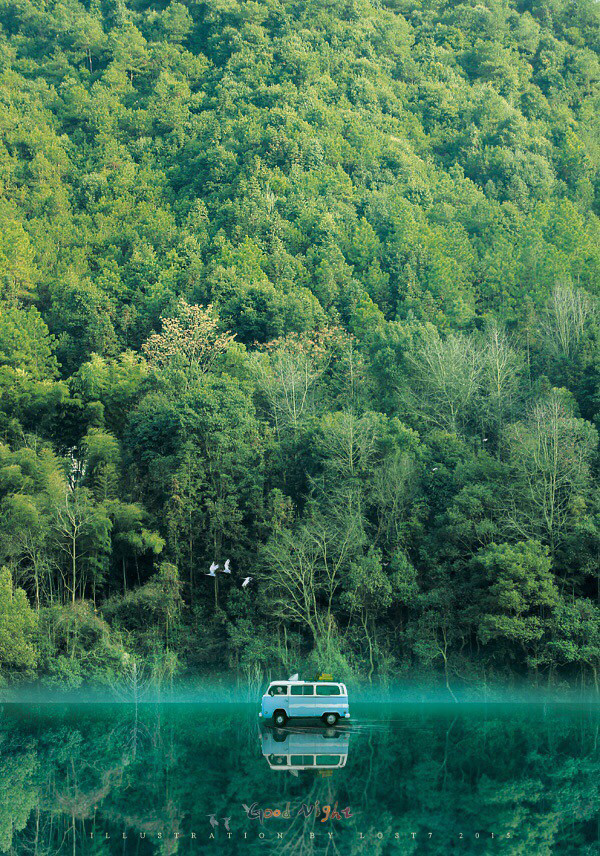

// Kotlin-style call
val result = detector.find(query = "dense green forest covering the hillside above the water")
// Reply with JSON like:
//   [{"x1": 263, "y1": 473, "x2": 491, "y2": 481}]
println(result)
[{"x1": 0, "y1": 0, "x2": 600, "y2": 691}]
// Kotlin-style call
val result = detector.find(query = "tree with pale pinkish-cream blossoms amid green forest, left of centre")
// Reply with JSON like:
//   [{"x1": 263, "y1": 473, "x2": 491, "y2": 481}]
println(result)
[{"x1": 142, "y1": 298, "x2": 235, "y2": 390}]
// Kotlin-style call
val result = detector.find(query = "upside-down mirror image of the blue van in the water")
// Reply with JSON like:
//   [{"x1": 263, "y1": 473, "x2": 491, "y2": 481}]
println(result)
[{"x1": 261, "y1": 726, "x2": 350, "y2": 776}]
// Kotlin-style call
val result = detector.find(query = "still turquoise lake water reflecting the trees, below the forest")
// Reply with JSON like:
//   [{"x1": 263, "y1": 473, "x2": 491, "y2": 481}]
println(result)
[{"x1": 0, "y1": 704, "x2": 600, "y2": 856}]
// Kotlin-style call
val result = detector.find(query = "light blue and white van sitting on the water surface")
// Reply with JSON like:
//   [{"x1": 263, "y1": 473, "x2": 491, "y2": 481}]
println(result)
[{"x1": 260, "y1": 676, "x2": 350, "y2": 727}]
